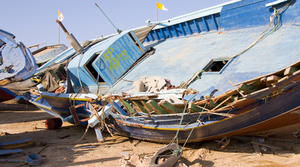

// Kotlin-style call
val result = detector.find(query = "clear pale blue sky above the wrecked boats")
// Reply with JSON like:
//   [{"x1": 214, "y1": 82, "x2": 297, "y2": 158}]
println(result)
[{"x1": 0, "y1": 0, "x2": 229, "y2": 46}]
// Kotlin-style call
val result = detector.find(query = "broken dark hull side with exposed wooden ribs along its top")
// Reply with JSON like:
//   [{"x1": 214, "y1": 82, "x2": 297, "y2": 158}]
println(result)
[{"x1": 104, "y1": 62, "x2": 300, "y2": 143}]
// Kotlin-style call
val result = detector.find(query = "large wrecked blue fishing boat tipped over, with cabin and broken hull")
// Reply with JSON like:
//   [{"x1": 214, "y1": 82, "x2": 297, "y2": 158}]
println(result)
[{"x1": 31, "y1": 0, "x2": 300, "y2": 142}]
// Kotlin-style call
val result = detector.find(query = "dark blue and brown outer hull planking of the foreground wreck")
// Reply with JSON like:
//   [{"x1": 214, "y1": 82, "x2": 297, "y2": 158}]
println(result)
[{"x1": 109, "y1": 72, "x2": 300, "y2": 143}]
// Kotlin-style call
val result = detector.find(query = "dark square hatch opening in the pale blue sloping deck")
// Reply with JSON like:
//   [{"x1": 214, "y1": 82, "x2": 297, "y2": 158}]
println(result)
[{"x1": 203, "y1": 58, "x2": 231, "y2": 72}]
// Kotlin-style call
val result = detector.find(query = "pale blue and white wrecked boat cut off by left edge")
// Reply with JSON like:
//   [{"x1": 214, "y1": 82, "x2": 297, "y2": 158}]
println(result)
[{"x1": 0, "y1": 30, "x2": 37, "y2": 101}]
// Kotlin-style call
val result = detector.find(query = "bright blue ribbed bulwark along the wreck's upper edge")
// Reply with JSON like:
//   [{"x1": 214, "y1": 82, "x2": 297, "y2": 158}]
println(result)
[{"x1": 147, "y1": 0, "x2": 300, "y2": 42}]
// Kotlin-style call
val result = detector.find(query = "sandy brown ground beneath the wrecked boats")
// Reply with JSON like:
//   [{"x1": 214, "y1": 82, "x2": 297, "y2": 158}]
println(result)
[{"x1": 0, "y1": 104, "x2": 300, "y2": 167}]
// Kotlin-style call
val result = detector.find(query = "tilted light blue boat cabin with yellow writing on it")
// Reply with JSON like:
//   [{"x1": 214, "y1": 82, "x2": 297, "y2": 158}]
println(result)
[{"x1": 68, "y1": 31, "x2": 146, "y2": 93}]
